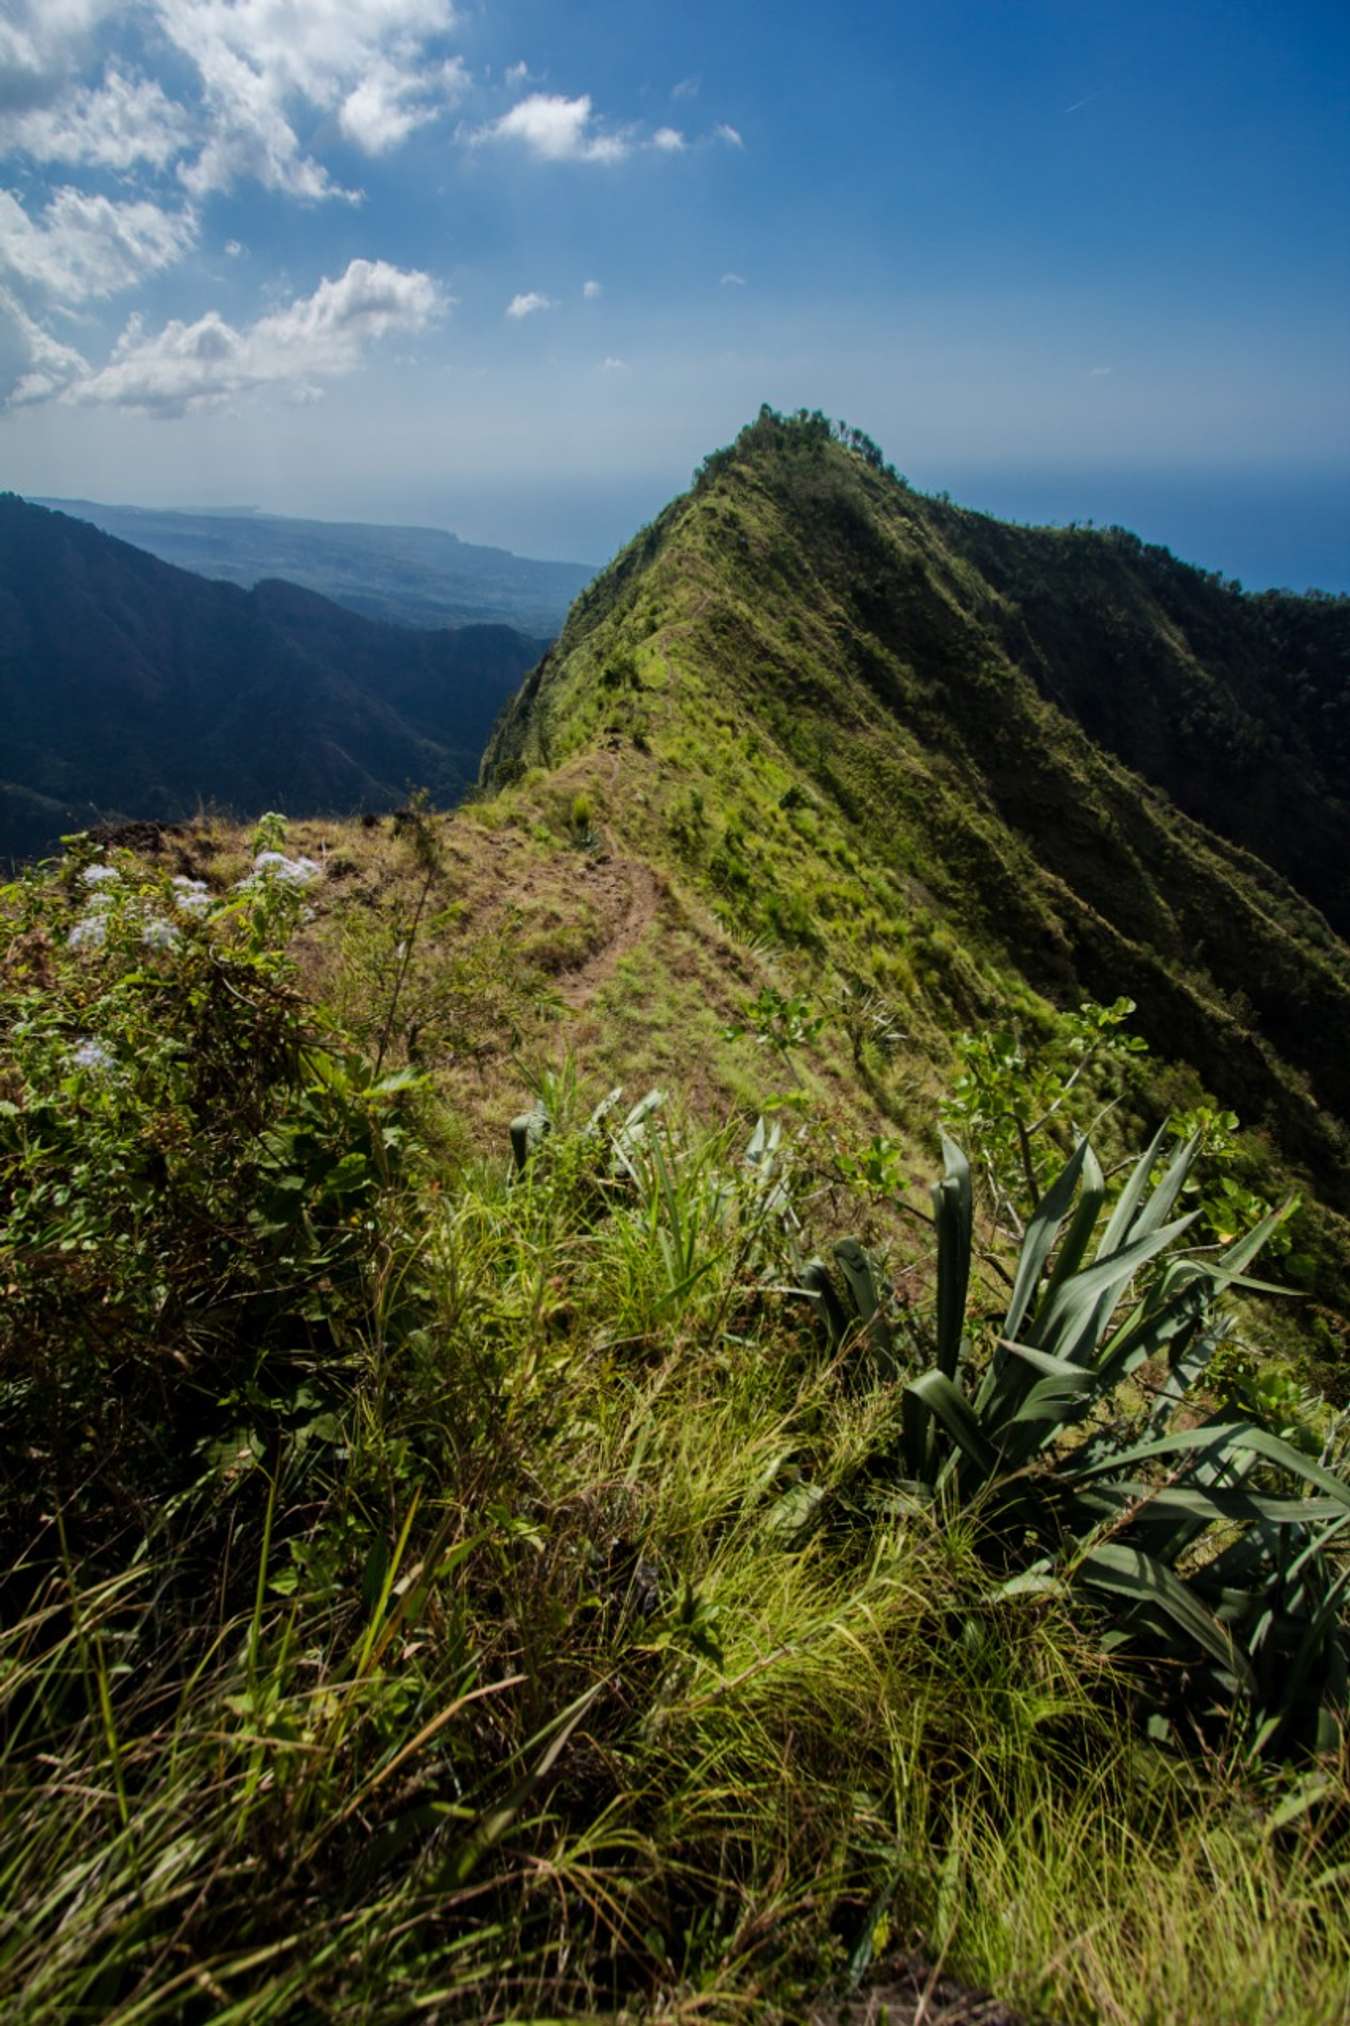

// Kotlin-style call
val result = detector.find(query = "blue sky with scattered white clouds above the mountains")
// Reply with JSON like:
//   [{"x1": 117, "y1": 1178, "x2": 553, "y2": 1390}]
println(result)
[{"x1": 0, "y1": 0, "x2": 1350, "y2": 588}]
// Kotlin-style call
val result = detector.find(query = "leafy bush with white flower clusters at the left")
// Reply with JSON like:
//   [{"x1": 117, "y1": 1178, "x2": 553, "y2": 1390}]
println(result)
[{"x1": 0, "y1": 839, "x2": 421, "y2": 1555}]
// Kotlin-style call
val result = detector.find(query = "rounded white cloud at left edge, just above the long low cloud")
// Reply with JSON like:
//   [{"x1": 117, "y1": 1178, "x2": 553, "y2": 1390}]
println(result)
[{"x1": 0, "y1": 186, "x2": 197, "y2": 302}]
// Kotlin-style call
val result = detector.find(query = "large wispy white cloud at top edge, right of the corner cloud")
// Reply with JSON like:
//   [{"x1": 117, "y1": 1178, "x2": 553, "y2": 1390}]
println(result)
[{"x1": 150, "y1": 0, "x2": 464, "y2": 199}]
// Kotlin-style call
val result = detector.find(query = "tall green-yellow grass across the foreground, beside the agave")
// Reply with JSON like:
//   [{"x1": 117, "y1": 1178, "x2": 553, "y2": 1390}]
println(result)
[{"x1": 0, "y1": 1092, "x2": 1350, "y2": 2026}]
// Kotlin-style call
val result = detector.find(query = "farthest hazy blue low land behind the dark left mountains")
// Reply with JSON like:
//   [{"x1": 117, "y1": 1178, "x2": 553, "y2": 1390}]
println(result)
[{"x1": 34, "y1": 498, "x2": 594, "y2": 638}]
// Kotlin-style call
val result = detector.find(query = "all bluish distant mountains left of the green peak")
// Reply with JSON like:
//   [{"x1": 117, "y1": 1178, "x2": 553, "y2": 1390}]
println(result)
[{"x1": 0, "y1": 494, "x2": 545, "y2": 857}]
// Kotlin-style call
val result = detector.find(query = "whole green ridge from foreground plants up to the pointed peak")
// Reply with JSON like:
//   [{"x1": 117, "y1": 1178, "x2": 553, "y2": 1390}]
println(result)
[{"x1": 0, "y1": 417, "x2": 1350, "y2": 2026}]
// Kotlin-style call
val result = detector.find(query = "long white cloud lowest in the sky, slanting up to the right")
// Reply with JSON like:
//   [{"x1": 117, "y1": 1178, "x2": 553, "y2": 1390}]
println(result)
[{"x1": 10, "y1": 259, "x2": 448, "y2": 417}]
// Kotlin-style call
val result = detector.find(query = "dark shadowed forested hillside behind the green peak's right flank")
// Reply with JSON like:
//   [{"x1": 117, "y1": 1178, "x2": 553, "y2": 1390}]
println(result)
[{"x1": 936, "y1": 500, "x2": 1350, "y2": 934}]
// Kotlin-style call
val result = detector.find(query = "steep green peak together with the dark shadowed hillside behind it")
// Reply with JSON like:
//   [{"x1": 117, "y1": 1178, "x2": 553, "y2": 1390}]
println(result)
[{"x1": 484, "y1": 413, "x2": 1350, "y2": 1210}]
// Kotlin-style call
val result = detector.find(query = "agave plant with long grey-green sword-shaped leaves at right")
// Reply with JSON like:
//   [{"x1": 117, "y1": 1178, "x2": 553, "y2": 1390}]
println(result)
[{"x1": 811, "y1": 1133, "x2": 1350, "y2": 1752}]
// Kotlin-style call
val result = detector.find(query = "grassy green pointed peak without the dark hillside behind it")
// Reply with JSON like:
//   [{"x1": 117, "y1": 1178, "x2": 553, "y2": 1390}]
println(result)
[{"x1": 486, "y1": 423, "x2": 1350, "y2": 1312}]
